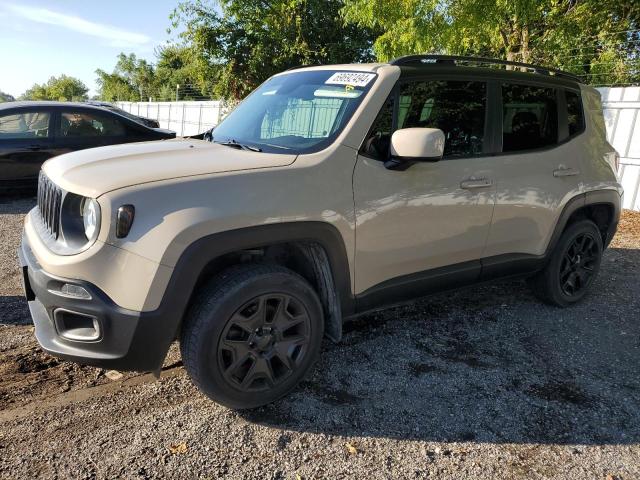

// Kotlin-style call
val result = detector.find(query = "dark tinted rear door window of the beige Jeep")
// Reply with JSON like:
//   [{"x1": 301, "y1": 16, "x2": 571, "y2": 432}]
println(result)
[{"x1": 502, "y1": 84, "x2": 558, "y2": 152}]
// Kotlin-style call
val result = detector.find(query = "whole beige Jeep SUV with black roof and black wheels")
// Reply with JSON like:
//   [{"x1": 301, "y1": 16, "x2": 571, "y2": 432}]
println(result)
[{"x1": 19, "y1": 56, "x2": 622, "y2": 408}]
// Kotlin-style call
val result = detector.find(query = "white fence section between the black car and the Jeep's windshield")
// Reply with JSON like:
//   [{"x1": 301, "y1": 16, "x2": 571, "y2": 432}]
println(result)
[{"x1": 116, "y1": 100, "x2": 227, "y2": 136}]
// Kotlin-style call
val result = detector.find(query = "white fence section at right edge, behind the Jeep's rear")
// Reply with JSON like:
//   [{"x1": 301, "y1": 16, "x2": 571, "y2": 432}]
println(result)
[{"x1": 598, "y1": 87, "x2": 640, "y2": 210}]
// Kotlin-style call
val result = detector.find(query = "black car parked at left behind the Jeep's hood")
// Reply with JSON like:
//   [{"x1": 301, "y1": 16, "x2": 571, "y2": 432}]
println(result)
[{"x1": 0, "y1": 102, "x2": 176, "y2": 191}]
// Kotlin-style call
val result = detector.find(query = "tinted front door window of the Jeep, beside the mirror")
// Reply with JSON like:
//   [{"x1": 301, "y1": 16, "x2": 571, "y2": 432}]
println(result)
[{"x1": 398, "y1": 81, "x2": 487, "y2": 157}]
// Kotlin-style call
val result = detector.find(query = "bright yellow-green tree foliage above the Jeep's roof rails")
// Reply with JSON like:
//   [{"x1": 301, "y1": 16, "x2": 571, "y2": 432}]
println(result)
[{"x1": 342, "y1": 0, "x2": 640, "y2": 83}]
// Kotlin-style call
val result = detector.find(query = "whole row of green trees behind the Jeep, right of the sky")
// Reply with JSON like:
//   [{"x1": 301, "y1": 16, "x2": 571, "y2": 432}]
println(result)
[{"x1": 91, "y1": 0, "x2": 640, "y2": 101}]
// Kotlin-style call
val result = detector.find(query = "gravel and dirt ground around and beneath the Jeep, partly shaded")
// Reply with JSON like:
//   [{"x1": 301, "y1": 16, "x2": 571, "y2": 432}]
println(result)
[{"x1": 0, "y1": 198, "x2": 640, "y2": 480}]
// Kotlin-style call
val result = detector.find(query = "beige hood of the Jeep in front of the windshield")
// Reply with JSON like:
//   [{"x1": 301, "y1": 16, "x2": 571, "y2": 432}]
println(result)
[{"x1": 42, "y1": 139, "x2": 296, "y2": 198}]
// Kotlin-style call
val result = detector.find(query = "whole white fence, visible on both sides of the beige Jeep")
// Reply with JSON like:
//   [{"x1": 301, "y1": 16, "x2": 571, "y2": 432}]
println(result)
[{"x1": 117, "y1": 91, "x2": 640, "y2": 210}]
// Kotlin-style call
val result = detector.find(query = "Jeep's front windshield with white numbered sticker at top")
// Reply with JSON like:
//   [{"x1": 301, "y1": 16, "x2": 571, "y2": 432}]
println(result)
[{"x1": 213, "y1": 70, "x2": 376, "y2": 154}]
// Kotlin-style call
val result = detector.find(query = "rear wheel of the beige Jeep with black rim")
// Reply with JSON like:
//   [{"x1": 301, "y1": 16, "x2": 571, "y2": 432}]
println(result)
[{"x1": 529, "y1": 220, "x2": 604, "y2": 307}]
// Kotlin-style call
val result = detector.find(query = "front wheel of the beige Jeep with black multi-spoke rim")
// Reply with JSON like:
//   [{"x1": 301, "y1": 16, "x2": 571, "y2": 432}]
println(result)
[{"x1": 180, "y1": 264, "x2": 324, "y2": 409}]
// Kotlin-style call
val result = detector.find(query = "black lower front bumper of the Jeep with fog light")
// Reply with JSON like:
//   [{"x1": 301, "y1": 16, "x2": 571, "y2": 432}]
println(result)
[{"x1": 18, "y1": 236, "x2": 177, "y2": 371}]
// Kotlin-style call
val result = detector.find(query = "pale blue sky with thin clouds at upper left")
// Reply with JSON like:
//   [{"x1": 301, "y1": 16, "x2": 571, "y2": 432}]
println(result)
[{"x1": 0, "y1": 0, "x2": 178, "y2": 97}]
